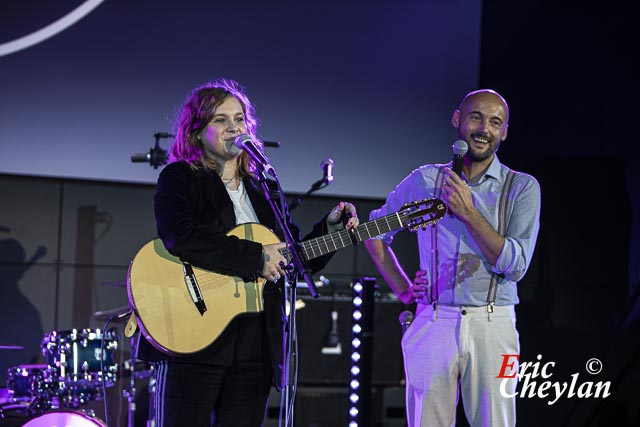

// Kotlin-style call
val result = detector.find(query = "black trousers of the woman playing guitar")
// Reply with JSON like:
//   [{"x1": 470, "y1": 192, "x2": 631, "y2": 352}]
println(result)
[{"x1": 153, "y1": 316, "x2": 273, "y2": 427}]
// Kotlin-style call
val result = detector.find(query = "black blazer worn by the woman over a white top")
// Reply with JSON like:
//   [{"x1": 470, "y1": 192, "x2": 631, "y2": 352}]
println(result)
[{"x1": 138, "y1": 162, "x2": 333, "y2": 388}]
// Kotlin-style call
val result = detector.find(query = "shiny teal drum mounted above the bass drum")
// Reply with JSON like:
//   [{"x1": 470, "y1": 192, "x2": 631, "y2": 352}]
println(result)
[{"x1": 40, "y1": 329, "x2": 118, "y2": 389}]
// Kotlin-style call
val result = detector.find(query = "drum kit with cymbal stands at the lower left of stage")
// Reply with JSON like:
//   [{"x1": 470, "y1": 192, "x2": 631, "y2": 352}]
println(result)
[{"x1": 0, "y1": 308, "x2": 155, "y2": 427}]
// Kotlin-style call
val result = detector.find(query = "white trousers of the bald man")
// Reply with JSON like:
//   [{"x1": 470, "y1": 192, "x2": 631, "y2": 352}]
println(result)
[{"x1": 402, "y1": 305, "x2": 520, "y2": 427}]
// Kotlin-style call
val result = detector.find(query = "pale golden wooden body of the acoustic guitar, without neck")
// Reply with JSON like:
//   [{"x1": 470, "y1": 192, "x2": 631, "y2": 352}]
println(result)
[{"x1": 127, "y1": 223, "x2": 280, "y2": 355}]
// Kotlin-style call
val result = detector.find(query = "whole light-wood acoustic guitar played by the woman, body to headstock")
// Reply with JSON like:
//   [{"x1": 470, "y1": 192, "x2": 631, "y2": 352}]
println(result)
[{"x1": 127, "y1": 198, "x2": 447, "y2": 355}]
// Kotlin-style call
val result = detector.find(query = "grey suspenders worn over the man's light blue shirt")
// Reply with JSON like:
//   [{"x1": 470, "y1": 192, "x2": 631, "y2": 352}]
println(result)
[{"x1": 430, "y1": 166, "x2": 516, "y2": 313}]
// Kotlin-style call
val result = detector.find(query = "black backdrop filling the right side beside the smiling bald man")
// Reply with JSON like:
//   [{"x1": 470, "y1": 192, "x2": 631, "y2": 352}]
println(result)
[{"x1": 480, "y1": 1, "x2": 640, "y2": 425}]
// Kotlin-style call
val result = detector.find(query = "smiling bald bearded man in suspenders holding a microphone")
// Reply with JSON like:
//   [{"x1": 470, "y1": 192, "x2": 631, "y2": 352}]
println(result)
[{"x1": 365, "y1": 89, "x2": 540, "y2": 427}]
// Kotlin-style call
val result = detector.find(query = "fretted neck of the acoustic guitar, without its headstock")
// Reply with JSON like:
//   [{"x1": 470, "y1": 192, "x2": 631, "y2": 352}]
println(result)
[{"x1": 292, "y1": 212, "x2": 403, "y2": 261}]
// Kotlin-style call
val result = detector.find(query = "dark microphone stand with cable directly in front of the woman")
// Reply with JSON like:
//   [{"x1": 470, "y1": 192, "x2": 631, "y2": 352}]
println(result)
[{"x1": 251, "y1": 164, "x2": 318, "y2": 426}]
